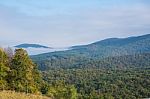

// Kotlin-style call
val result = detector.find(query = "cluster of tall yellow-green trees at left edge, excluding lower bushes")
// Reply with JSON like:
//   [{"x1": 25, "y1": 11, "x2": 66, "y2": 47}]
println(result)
[{"x1": 0, "y1": 49, "x2": 42, "y2": 93}]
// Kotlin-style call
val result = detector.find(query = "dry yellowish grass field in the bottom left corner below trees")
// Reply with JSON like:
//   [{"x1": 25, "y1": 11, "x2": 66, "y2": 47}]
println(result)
[{"x1": 0, "y1": 91, "x2": 51, "y2": 99}]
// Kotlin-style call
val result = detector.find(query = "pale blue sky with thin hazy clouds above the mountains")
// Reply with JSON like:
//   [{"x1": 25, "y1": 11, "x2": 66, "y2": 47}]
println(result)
[{"x1": 0, "y1": 0, "x2": 150, "y2": 47}]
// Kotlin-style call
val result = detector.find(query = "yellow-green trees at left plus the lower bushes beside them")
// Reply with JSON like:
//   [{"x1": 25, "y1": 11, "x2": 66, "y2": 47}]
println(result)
[{"x1": 0, "y1": 49, "x2": 77, "y2": 99}]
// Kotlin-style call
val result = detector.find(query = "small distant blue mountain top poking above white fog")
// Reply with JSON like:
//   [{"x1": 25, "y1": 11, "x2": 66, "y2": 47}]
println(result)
[{"x1": 14, "y1": 43, "x2": 50, "y2": 48}]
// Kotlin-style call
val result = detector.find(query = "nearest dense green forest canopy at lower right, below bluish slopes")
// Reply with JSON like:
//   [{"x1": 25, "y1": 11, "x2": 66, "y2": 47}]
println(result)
[{"x1": 43, "y1": 68, "x2": 150, "y2": 99}]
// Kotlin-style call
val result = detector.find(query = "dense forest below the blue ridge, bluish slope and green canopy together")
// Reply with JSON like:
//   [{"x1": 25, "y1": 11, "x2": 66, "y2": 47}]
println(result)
[{"x1": 35, "y1": 53, "x2": 150, "y2": 99}]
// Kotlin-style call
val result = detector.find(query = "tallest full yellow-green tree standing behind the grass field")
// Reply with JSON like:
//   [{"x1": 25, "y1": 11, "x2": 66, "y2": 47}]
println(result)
[{"x1": 10, "y1": 49, "x2": 38, "y2": 93}]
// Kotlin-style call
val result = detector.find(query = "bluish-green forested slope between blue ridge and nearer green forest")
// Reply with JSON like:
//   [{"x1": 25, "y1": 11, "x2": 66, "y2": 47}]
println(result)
[{"x1": 32, "y1": 53, "x2": 150, "y2": 71}]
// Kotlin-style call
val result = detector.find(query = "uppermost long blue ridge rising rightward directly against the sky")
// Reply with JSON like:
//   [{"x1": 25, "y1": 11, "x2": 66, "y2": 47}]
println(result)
[{"x1": 32, "y1": 34, "x2": 150, "y2": 59}]
